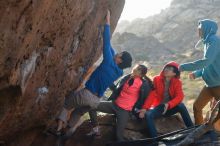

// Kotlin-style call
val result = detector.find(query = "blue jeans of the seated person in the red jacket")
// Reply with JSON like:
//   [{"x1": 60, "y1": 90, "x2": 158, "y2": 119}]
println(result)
[{"x1": 145, "y1": 103, "x2": 193, "y2": 138}]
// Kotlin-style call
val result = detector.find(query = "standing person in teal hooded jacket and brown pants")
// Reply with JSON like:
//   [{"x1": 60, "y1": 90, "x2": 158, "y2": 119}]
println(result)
[{"x1": 179, "y1": 19, "x2": 220, "y2": 125}]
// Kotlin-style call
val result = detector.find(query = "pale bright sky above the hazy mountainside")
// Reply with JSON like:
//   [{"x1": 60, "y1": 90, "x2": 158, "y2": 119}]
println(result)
[{"x1": 120, "y1": 0, "x2": 172, "y2": 21}]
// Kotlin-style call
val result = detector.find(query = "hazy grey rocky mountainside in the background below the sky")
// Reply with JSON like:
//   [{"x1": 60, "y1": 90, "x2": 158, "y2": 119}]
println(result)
[{"x1": 113, "y1": 0, "x2": 220, "y2": 65}]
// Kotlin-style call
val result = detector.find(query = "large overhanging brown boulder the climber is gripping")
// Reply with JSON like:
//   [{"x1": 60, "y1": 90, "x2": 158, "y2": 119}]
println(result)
[{"x1": 0, "y1": 0, "x2": 124, "y2": 146}]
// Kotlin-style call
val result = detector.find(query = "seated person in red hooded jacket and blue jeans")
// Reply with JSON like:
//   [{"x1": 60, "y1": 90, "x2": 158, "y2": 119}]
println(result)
[{"x1": 139, "y1": 62, "x2": 193, "y2": 137}]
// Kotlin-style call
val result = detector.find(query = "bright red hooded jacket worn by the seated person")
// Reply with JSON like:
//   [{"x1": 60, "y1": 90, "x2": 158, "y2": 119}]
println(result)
[{"x1": 143, "y1": 62, "x2": 184, "y2": 110}]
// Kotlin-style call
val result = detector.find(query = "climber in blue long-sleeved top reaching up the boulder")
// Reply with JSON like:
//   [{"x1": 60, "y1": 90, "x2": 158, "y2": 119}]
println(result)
[{"x1": 50, "y1": 10, "x2": 132, "y2": 136}]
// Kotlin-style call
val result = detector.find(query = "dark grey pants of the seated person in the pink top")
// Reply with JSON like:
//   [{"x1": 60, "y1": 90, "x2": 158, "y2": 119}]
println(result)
[{"x1": 90, "y1": 101, "x2": 130, "y2": 141}]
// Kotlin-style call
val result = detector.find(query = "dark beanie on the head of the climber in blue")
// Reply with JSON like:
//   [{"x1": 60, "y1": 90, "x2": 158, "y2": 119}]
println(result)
[{"x1": 118, "y1": 51, "x2": 132, "y2": 69}]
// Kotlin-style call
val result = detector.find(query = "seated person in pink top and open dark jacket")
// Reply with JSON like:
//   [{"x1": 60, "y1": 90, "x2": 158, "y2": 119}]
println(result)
[{"x1": 87, "y1": 65, "x2": 153, "y2": 141}]
